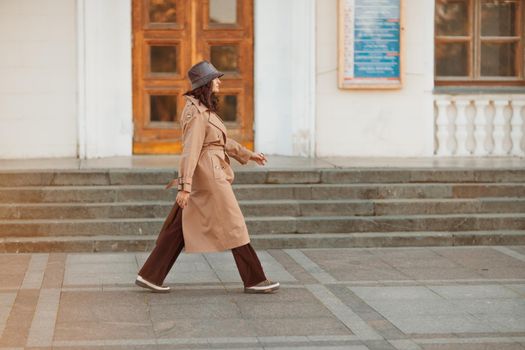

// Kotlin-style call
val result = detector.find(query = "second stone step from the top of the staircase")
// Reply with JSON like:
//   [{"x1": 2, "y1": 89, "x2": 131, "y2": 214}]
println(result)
[{"x1": 0, "y1": 183, "x2": 525, "y2": 204}]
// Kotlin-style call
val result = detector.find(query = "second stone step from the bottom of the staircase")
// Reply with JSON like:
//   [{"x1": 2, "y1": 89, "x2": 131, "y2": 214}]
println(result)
[{"x1": 0, "y1": 213, "x2": 525, "y2": 237}]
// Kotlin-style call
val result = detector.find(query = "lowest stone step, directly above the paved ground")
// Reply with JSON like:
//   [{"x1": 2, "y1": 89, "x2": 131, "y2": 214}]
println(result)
[{"x1": 0, "y1": 230, "x2": 525, "y2": 253}]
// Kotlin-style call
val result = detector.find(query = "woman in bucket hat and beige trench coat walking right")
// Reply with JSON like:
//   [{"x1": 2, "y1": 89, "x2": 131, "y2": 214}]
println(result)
[{"x1": 135, "y1": 61, "x2": 279, "y2": 293}]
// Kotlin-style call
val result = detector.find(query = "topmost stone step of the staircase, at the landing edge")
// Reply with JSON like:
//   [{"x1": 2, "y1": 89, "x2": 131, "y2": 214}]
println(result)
[{"x1": 0, "y1": 167, "x2": 525, "y2": 187}]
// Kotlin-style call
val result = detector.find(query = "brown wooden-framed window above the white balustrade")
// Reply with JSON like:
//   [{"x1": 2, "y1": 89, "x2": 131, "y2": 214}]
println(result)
[{"x1": 434, "y1": 0, "x2": 525, "y2": 85}]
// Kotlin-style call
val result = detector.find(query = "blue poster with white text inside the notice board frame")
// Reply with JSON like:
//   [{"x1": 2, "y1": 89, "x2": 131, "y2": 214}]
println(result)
[{"x1": 353, "y1": 0, "x2": 401, "y2": 79}]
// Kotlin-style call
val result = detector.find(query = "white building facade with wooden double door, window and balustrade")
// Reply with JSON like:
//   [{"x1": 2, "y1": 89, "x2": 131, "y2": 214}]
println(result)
[{"x1": 0, "y1": 0, "x2": 525, "y2": 159}]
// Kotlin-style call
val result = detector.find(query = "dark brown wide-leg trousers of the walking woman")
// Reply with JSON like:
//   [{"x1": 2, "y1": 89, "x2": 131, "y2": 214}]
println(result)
[{"x1": 139, "y1": 203, "x2": 266, "y2": 287}]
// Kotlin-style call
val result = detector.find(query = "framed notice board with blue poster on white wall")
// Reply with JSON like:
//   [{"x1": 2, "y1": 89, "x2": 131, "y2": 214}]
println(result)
[{"x1": 338, "y1": 0, "x2": 403, "y2": 89}]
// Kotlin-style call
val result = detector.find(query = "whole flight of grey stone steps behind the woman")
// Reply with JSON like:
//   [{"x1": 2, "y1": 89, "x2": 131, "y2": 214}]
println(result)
[{"x1": 0, "y1": 168, "x2": 525, "y2": 252}]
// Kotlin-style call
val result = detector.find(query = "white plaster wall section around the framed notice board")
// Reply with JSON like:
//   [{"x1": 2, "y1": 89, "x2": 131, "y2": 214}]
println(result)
[{"x1": 316, "y1": 0, "x2": 434, "y2": 157}]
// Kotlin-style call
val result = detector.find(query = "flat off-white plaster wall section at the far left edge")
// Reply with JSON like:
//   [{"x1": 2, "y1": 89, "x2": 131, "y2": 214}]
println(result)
[{"x1": 0, "y1": 0, "x2": 77, "y2": 158}]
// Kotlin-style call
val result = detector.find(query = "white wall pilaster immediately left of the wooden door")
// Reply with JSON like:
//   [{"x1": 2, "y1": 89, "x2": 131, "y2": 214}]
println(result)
[{"x1": 78, "y1": 0, "x2": 133, "y2": 158}]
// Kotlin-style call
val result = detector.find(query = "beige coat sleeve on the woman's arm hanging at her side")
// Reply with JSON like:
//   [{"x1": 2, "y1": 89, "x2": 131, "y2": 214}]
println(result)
[{"x1": 177, "y1": 109, "x2": 207, "y2": 192}]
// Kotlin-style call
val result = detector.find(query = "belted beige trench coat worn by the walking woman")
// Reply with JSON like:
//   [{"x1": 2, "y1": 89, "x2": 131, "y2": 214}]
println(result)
[{"x1": 167, "y1": 96, "x2": 253, "y2": 253}]
